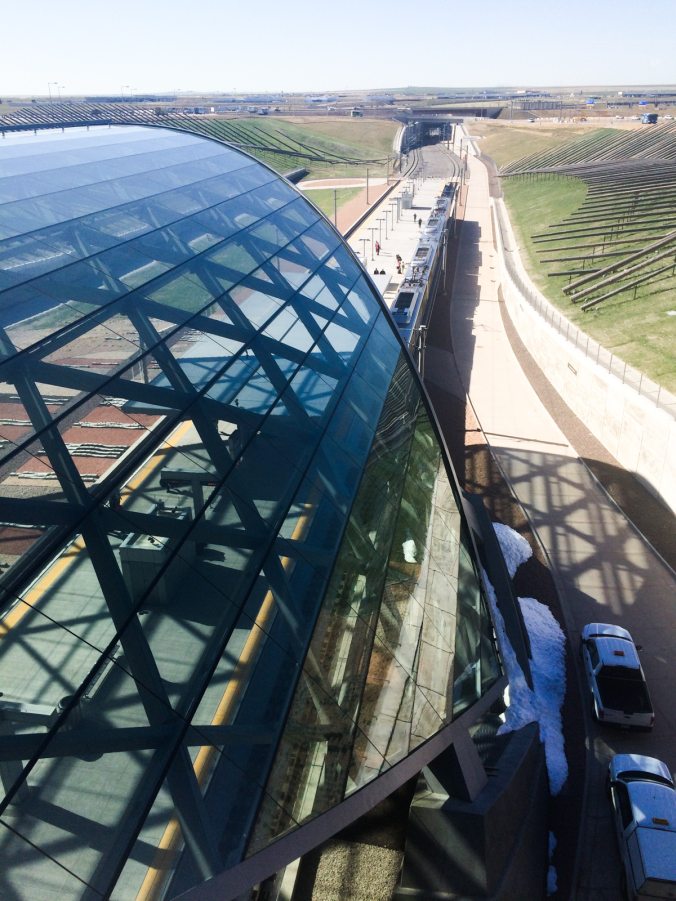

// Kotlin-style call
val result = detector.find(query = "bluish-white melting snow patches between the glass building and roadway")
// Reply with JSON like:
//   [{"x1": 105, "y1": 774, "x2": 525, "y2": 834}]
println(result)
[{"x1": 487, "y1": 523, "x2": 568, "y2": 795}]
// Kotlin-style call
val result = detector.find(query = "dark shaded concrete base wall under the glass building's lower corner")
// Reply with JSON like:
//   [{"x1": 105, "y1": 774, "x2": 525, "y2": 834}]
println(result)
[{"x1": 393, "y1": 723, "x2": 549, "y2": 901}]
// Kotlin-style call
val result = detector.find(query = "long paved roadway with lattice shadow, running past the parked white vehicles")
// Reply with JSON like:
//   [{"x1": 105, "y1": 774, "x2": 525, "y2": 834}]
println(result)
[{"x1": 446, "y1": 130, "x2": 676, "y2": 899}]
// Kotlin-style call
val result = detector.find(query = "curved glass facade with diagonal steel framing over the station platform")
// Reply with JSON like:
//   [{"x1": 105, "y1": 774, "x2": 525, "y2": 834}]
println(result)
[{"x1": 0, "y1": 127, "x2": 498, "y2": 899}]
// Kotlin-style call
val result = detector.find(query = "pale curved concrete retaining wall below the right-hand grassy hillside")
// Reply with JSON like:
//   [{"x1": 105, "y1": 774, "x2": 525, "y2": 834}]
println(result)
[{"x1": 496, "y1": 201, "x2": 676, "y2": 512}]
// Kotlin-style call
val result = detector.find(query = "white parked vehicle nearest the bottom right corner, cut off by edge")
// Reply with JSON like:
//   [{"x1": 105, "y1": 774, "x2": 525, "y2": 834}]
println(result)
[{"x1": 608, "y1": 754, "x2": 676, "y2": 899}]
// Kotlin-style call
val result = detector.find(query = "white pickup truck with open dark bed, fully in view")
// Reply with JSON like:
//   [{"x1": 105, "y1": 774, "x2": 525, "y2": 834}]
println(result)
[{"x1": 580, "y1": 623, "x2": 655, "y2": 729}]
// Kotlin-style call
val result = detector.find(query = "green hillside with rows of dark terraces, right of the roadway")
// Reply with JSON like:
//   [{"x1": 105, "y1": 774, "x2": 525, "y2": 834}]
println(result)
[{"x1": 499, "y1": 123, "x2": 676, "y2": 391}]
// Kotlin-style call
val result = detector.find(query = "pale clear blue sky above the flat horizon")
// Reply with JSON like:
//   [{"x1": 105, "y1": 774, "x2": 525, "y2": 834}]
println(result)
[{"x1": 0, "y1": 0, "x2": 676, "y2": 100}]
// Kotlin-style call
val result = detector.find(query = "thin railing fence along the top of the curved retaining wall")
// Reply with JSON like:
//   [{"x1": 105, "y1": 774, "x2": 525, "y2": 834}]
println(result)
[{"x1": 494, "y1": 203, "x2": 676, "y2": 418}]
